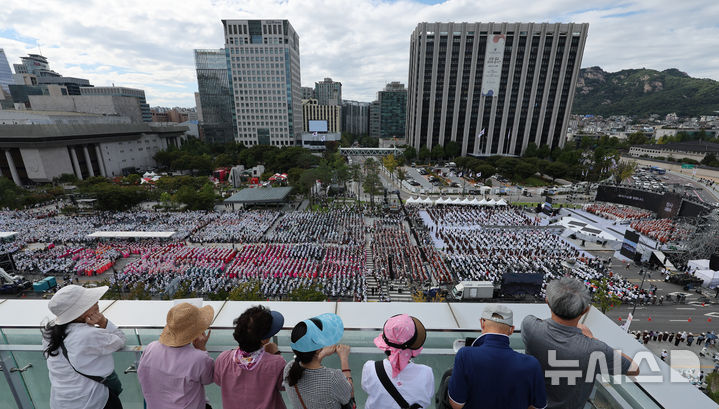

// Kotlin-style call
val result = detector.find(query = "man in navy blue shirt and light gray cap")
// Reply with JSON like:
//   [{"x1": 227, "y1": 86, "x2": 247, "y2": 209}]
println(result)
[{"x1": 449, "y1": 304, "x2": 547, "y2": 409}]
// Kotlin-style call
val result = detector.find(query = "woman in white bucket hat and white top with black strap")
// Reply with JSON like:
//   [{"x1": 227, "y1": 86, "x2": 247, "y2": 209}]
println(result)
[{"x1": 43, "y1": 285, "x2": 126, "y2": 409}]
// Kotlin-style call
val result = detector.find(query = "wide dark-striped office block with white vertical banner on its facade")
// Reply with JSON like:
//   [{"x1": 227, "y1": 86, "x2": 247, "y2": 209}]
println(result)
[{"x1": 407, "y1": 23, "x2": 589, "y2": 155}]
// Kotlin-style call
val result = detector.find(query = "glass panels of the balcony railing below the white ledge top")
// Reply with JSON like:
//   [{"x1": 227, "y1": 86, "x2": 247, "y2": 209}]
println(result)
[{"x1": 0, "y1": 328, "x2": 661, "y2": 409}]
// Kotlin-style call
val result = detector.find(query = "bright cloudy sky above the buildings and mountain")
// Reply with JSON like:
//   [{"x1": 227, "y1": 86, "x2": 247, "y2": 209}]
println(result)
[{"x1": 0, "y1": 0, "x2": 719, "y2": 107}]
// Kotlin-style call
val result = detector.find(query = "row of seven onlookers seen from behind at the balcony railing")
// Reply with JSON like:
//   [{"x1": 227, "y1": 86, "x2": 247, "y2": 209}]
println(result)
[{"x1": 42, "y1": 277, "x2": 651, "y2": 409}]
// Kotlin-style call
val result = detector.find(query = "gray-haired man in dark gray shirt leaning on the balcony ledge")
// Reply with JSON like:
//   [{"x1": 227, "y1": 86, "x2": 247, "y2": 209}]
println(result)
[{"x1": 521, "y1": 277, "x2": 639, "y2": 409}]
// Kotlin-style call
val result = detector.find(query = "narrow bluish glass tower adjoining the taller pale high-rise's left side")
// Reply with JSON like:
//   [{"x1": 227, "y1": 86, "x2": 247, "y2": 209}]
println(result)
[{"x1": 195, "y1": 48, "x2": 237, "y2": 143}]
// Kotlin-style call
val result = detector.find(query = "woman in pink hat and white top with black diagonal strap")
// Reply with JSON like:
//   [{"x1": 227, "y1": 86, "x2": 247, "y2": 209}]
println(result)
[{"x1": 362, "y1": 314, "x2": 434, "y2": 409}]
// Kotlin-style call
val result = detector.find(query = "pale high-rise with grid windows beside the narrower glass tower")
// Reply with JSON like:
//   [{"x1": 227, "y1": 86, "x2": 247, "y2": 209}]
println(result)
[{"x1": 222, "y1": 20, "x2": 302, "y2": 146}]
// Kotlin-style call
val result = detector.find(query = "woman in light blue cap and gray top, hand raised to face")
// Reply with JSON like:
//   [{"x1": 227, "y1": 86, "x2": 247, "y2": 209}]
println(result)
[{"x1": 284, "y1": 314, "x2": 354, "y2": 409}]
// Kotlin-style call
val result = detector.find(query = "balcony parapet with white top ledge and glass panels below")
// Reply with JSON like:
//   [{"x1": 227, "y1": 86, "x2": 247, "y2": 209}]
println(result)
[{"x1": 0, "y1": 300, "x2": 716, "y2": 409}]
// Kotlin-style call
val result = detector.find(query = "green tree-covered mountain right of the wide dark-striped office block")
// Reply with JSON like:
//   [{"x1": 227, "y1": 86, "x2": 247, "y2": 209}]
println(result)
[{"x1": 572, "y1": 67, "x2": 719, "y2": 117}]
